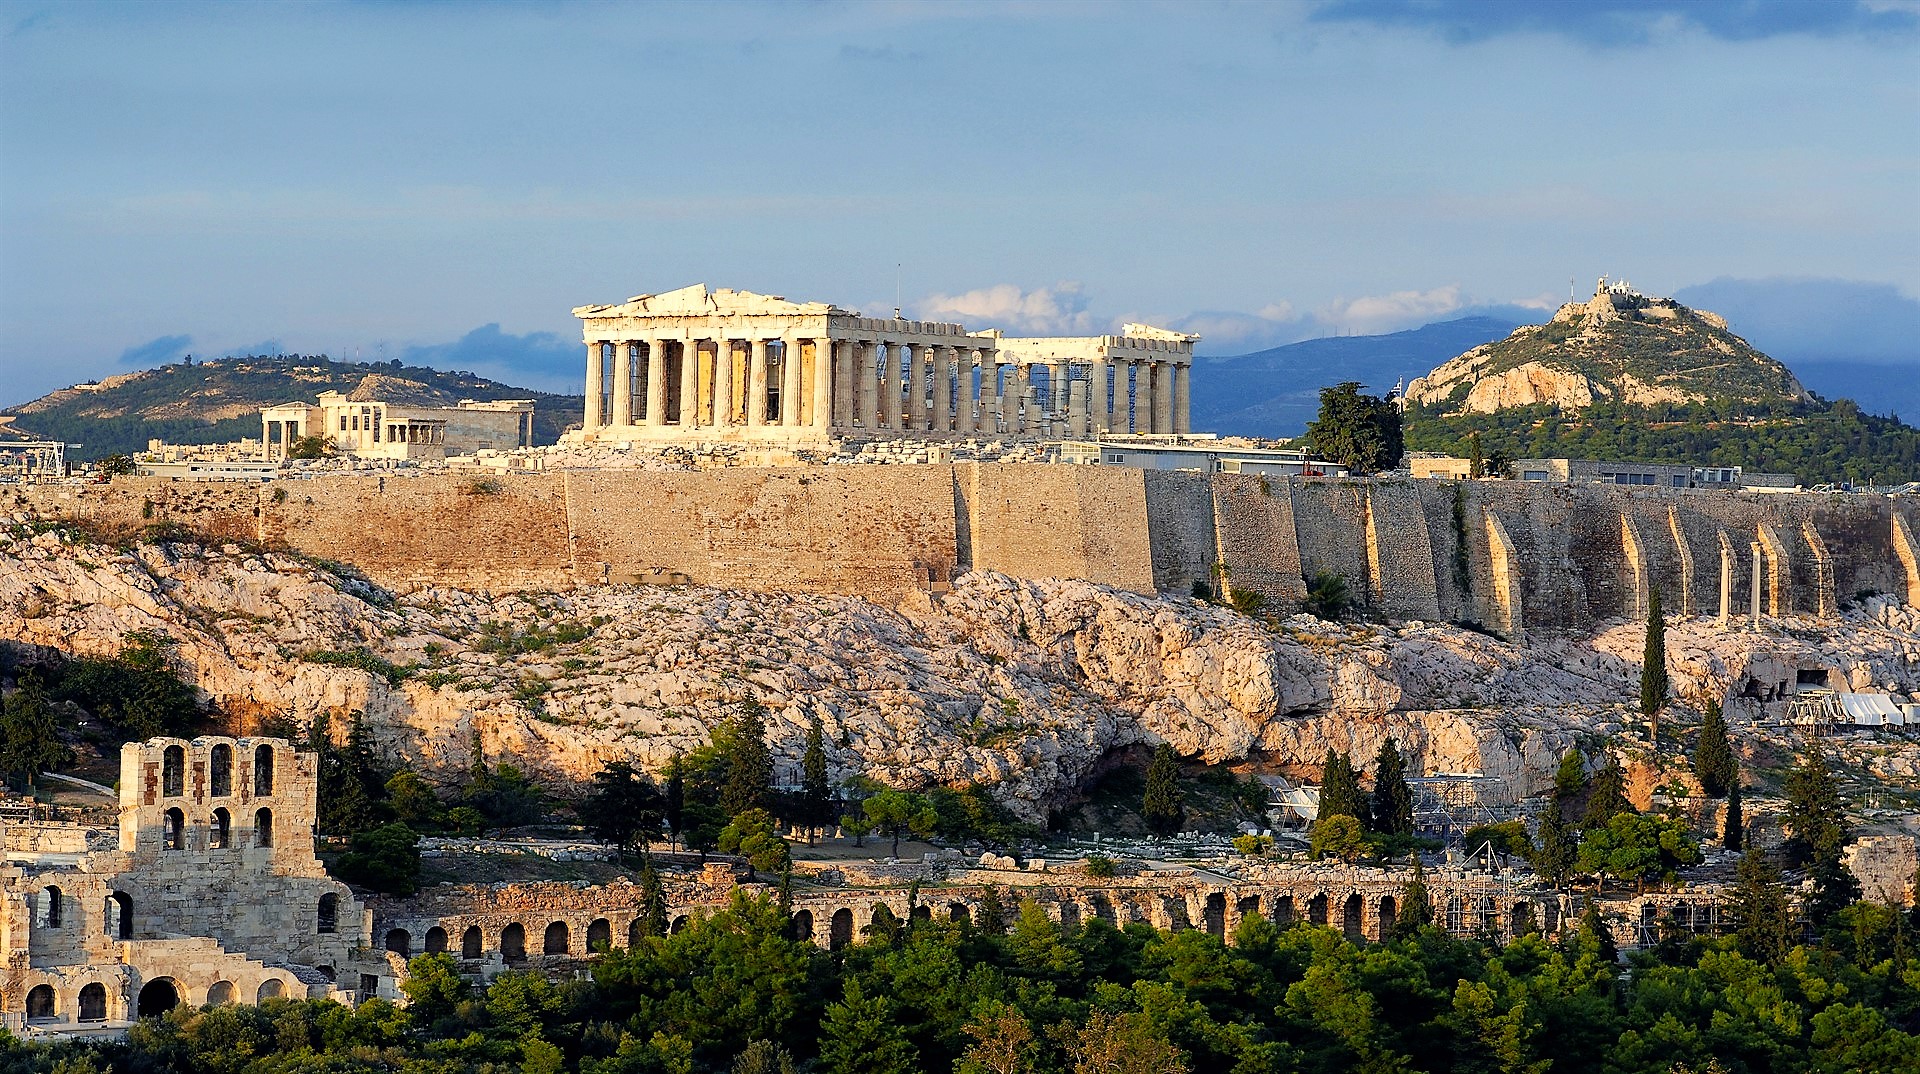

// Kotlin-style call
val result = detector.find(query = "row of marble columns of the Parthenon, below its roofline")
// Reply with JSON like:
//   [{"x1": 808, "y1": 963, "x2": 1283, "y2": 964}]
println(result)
[{"x1": 586, "y1": 338, "x2": 1192, "y2": 438}]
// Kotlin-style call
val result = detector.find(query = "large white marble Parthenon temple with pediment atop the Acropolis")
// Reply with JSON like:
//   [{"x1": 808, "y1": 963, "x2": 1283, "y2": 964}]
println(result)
[{"x1": 572, "y1": 284, "x2": 1198, "y2": 444}]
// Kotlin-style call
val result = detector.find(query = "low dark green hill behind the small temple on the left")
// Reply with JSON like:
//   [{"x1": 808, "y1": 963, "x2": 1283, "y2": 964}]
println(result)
[{"x1": 4, "y1": 354, "x2": 582, "y2": 459}]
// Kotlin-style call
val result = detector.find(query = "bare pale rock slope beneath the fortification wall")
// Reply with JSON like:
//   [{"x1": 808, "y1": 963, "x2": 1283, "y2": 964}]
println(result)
[{"x1": 11, "y1": 534, "x2": 1920, "y2": 817}]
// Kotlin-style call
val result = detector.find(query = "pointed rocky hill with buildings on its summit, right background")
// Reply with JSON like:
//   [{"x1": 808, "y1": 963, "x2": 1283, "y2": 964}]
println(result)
[{"x1": 1405, "y1": 281, "x2": 1811, "y2": 415}]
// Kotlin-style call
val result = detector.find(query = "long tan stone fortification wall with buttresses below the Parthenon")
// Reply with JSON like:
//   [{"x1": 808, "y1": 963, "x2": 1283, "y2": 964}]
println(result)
[{"x1": 0, "y1": 463, "x2": 1920, "y2": 634}]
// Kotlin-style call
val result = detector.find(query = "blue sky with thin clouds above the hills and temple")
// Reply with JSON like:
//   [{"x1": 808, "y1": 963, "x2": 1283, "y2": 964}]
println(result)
[{"x1": 0, "y1": 0, "x2": 1920, "y2": 403}]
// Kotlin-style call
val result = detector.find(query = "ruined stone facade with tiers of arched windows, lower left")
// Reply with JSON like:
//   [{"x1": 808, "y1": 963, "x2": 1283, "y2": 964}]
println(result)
[{"x1": 0, "y1": 738, "x2": 394, "y2": 1037}]
